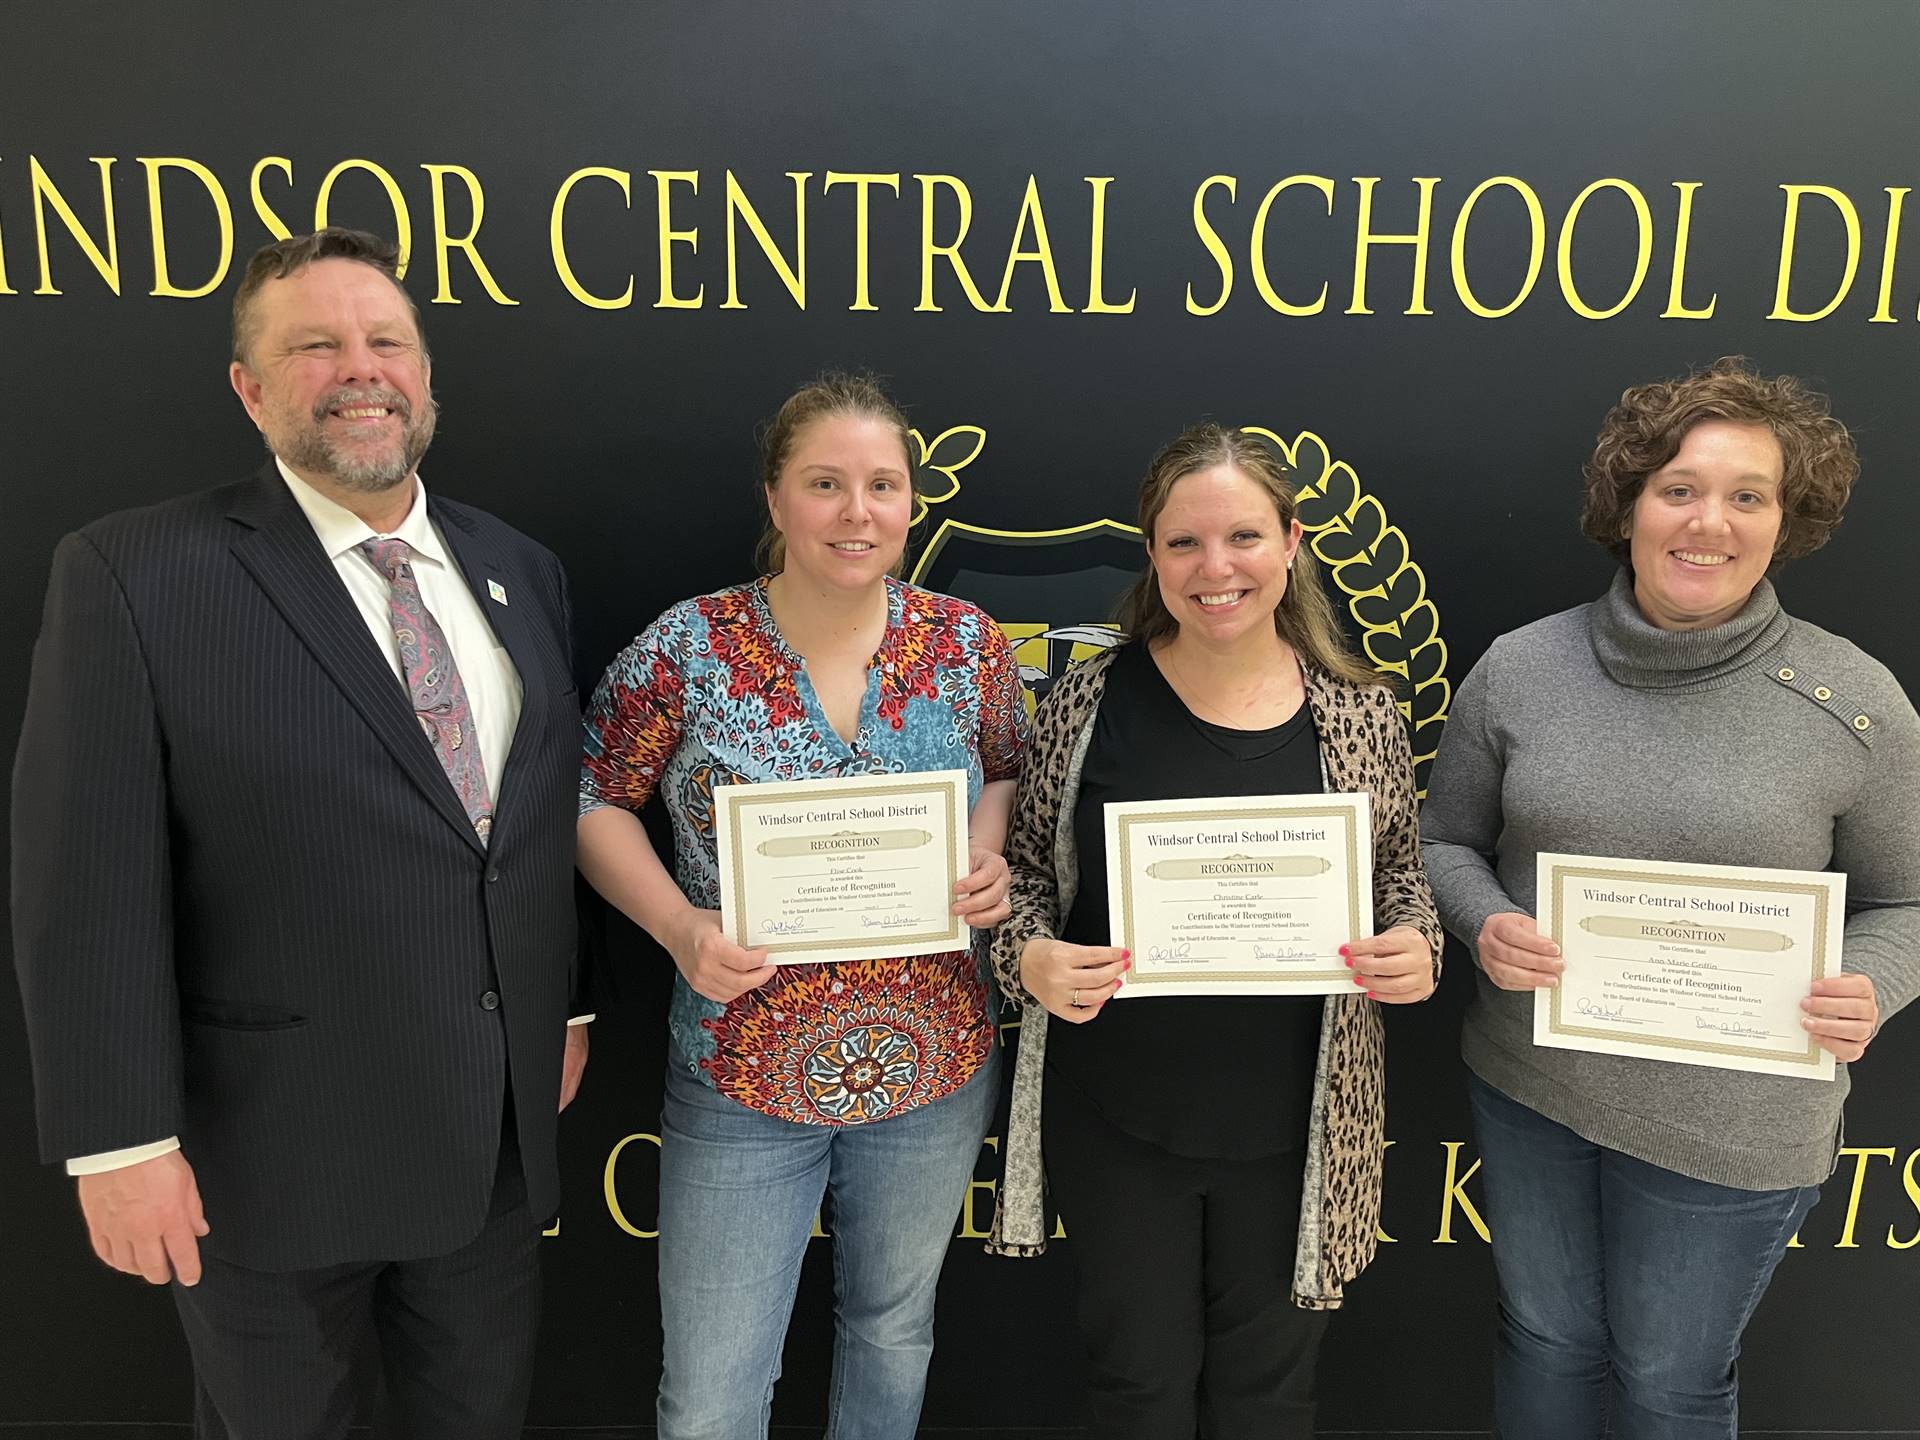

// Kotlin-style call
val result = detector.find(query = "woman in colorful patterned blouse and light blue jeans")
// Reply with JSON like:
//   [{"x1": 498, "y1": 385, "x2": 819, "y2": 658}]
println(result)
[{"x1": 580, "y1": 376, "x2": 1025, "y2": 1440}]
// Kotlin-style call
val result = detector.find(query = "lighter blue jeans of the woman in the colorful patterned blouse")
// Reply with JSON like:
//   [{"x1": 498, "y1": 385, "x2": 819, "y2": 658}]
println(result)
[{"x1": 659, "y1": 1046, "x2": 998, "y2": 1440}]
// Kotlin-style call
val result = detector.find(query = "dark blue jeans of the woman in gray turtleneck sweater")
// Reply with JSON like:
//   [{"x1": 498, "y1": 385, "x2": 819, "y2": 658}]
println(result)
[{"x1": 1469, "y1": 1077, "x2": 1820, "y2": 1440}]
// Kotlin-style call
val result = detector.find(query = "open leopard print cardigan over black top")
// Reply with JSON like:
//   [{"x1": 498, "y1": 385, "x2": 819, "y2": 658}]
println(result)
[{"x1": 987, "y1": 653, "x2": 1444, "y2": 1309}]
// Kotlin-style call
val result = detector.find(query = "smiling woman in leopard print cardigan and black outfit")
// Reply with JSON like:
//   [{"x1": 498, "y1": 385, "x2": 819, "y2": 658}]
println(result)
[{"x1": 987, "y1": 426, "x2": 1442, "y2": 1436}]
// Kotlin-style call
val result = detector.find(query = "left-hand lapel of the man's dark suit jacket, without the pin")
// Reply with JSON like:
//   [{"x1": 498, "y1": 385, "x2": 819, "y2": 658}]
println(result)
[{"x1": 228, "y1": 463, "x2": 486, "y2": 851}]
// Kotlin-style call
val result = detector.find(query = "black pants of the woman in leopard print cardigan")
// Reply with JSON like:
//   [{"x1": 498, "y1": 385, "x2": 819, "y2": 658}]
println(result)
[{"x1": 1041, "y1": 1079, "x2": 1327, "y2": 1440}]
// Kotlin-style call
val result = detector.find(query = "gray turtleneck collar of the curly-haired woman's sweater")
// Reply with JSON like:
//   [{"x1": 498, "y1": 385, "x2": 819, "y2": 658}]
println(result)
[{"x1": 1586, "y1": 570, "x2": 1793, "y2": 691}]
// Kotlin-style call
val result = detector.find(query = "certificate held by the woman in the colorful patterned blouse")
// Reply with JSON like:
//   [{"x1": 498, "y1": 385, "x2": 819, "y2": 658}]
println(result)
[{"x1": 714, "y1": 770, "x2": 973, "y2": 966}]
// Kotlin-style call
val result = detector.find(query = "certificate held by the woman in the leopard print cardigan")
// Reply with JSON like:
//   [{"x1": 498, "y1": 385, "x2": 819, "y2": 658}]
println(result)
[{"x1": 1106, "y1": 795, "x2": 1373, "y2": 1000}]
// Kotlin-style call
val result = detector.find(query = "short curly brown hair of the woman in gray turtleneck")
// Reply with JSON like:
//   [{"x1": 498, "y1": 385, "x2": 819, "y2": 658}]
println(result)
[{"x1": 1580, "y1": 355, "x2": 1860, "y2": 566}]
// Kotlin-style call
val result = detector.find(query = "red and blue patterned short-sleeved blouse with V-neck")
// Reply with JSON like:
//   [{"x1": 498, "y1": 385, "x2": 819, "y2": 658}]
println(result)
[{"x1": 580, "y1": 580, "x2": 1027, "y2": 1125}]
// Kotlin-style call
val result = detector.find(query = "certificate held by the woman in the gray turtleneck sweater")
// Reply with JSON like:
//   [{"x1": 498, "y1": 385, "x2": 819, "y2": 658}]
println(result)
[{"x1": 1534, "y1": 854, "x2": 1847, "y2": 1081}]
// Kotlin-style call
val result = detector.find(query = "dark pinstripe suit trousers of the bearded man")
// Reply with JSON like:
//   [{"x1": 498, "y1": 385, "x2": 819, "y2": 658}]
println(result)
[{"x1": 173, "y1": 1110, "x2": 540, "y2": 1440}]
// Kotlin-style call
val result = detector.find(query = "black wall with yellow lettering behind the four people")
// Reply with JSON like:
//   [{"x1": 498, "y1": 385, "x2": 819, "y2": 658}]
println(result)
[{"x1": 0, "y1": 0, "x2": 1920, "y2": 1434}]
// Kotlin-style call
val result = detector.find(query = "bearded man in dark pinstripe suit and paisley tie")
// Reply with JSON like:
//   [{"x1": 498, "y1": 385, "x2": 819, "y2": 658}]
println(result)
[{"x1": 13, "y1": 230, "x2": 589, "y2": 1440}]
